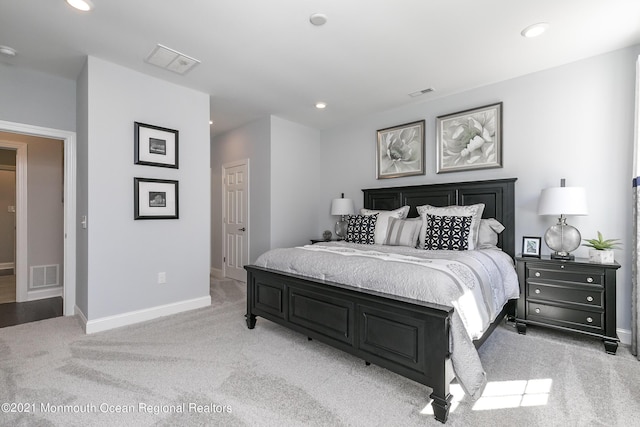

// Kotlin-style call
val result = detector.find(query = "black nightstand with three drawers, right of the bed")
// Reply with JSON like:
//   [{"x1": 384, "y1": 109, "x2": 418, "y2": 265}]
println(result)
[{"x1": 516, "y1": 257, "x2": 620, "y2": 354}]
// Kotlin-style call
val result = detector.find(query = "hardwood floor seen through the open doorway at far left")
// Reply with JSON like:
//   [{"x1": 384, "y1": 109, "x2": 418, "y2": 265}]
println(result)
[{"x1": 0, "y1": 275, "x2": 62, "y2": 328}]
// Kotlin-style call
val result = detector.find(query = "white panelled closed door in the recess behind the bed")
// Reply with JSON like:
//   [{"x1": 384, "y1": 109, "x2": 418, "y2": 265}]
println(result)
[{"x1": 222, "y1": 159, "x2": 249, "y2": 282}]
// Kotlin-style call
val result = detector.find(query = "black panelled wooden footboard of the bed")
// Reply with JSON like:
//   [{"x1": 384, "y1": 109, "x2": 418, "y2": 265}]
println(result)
[{"x1": 245, "y1": 266, "x2": 454, "y2": 423}]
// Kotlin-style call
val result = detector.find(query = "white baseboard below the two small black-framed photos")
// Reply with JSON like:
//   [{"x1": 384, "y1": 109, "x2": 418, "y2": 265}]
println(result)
[{"x1": 84, "y1": 295, "x2": 211, "y2": 334}]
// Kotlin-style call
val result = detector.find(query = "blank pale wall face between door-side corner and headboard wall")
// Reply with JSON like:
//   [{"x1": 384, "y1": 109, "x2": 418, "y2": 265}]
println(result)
[{"x1": 271, "y1": 117, "x2": 322, "y2": 248}]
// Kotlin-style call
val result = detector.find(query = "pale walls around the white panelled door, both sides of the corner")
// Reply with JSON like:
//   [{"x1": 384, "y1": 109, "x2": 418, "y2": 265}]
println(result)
[{"x1": 211, "y1": 116, "x2": 329, "y2": 269}]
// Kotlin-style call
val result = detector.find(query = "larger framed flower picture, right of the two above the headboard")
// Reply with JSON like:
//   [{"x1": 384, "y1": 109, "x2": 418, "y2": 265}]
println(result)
[{"x1": 436, "y1": 102, "x2": 502, "y2": 173}]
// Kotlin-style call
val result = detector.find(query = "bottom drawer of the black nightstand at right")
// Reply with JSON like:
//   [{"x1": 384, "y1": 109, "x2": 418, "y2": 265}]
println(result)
[{"x1": 527, "y1": 301, "x2": 604, "y2": 333}]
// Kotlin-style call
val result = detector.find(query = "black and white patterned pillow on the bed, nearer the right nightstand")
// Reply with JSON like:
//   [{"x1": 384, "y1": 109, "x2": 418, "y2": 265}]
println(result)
[{"x1": 424, "y1": 214, "x2": 471, "y2": 251}]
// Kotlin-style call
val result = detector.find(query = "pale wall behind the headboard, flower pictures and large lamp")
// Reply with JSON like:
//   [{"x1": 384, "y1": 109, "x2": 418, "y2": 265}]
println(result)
[{"x1": 318, "y1": 46, "x2": 640, "y2": 330}]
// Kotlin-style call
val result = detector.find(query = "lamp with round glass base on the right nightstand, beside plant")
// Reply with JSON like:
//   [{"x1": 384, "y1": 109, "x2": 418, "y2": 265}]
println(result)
[{"x1": 538, "y1": 179, "x2": 589, "y2": 259}]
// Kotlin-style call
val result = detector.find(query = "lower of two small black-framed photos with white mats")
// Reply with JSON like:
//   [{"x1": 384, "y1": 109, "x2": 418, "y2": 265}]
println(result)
[{"x1": 133, "y1": 177, "x2": 179, "y2": 220}]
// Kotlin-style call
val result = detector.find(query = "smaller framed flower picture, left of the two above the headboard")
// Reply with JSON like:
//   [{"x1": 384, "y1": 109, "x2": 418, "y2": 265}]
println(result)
[{"x1": 376, "y1": 120, "x2": 425, "y2": 179}]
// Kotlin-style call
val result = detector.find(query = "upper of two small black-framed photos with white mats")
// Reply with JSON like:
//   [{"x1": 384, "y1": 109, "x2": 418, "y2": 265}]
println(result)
[{"x1": 134, "y1": 122, "x2": 178, "y2": 169}]
